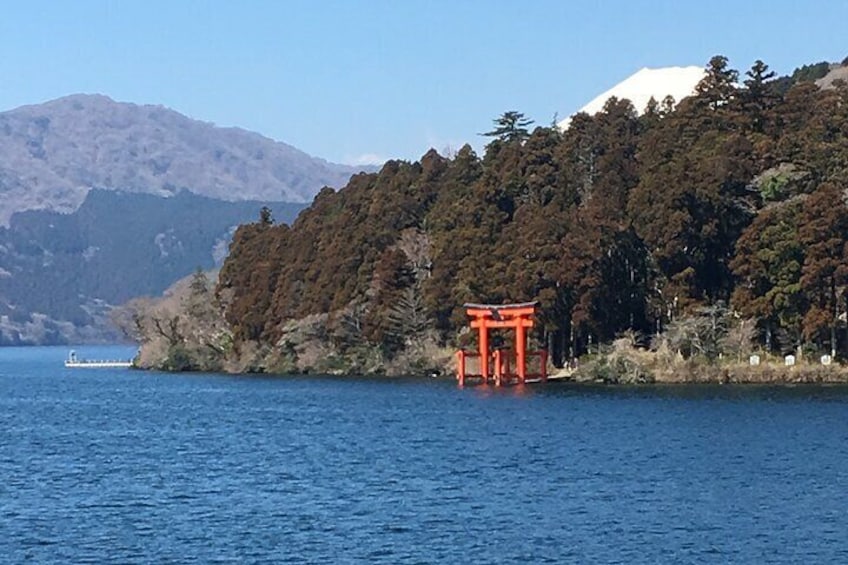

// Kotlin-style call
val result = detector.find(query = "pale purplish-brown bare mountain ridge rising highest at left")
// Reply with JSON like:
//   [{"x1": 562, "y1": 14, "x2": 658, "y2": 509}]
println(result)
[{"x1": 0, "y1": 94, "x2": 362, "y2": 225}]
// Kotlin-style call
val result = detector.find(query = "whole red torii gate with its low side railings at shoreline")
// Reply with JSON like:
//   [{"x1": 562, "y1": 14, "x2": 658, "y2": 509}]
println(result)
[{"x1": 457, "y1": 302, "x2": 547, "y2": 386}]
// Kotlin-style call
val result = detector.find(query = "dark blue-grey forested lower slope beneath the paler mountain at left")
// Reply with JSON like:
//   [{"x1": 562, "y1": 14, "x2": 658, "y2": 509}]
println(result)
[{"x1": 0, "y1": 190, "x2": 305, "y2": 345}]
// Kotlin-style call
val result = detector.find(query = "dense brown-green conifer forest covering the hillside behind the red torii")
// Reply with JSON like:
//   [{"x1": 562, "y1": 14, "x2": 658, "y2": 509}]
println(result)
[{"x1": 136, "y1": 56, "x2": 848, "y2": 374}]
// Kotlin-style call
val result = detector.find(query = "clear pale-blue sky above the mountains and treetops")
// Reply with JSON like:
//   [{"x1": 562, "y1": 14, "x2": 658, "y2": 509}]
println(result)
[{"x1": 0, "y1": 0, "x2": 848, "y2": 162}]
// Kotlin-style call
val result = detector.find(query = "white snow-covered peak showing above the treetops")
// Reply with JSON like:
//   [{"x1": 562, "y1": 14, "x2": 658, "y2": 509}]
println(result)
[{"x1": 557, "y1": 66, "x2": 706, "y2": 129}]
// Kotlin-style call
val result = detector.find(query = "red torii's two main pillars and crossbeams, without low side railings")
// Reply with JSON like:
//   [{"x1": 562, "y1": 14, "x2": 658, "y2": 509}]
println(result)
[{"x1": 464, "y1": 302, "x2": 539, "y2": 383}]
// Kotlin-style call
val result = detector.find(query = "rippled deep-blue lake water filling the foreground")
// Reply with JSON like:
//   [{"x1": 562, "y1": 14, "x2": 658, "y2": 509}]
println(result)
[{"x1": 0, "y1": 348, "x2": 848, "y2": 564}]
